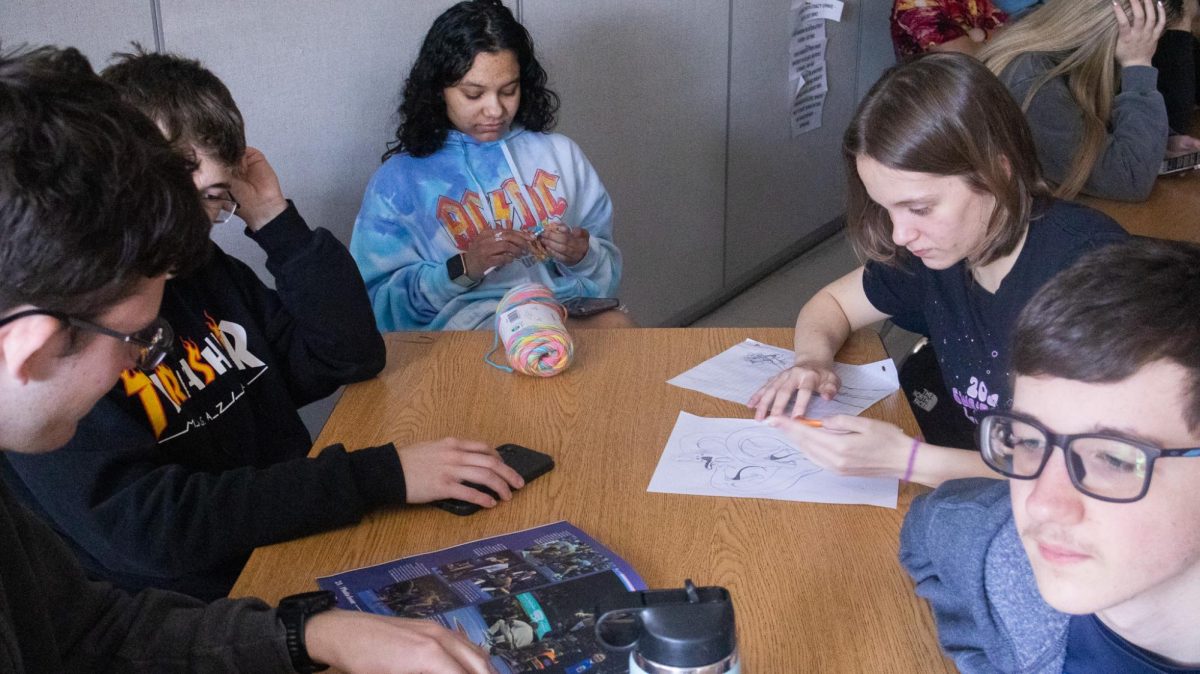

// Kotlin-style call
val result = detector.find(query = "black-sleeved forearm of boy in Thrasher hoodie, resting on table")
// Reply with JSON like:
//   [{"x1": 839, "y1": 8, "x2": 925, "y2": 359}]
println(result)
[{"x1": 82, "y1": 445, "x2": 406, "y2": 568}]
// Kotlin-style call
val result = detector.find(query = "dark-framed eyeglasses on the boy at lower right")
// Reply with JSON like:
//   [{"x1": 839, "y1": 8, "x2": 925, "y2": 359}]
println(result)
[{"x1": 979, "y1": 413, "x2": 1200, "y2": 504}]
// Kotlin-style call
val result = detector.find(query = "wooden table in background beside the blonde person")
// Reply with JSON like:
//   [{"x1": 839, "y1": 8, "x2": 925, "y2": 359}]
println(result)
[{"x1": 1079, "y1": 170, "x2": 1200, "y2": 243}]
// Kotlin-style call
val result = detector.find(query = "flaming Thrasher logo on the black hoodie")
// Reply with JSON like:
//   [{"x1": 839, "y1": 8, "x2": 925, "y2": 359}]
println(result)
[{"x1": 121, "y1": 312, "x2": 266, "y2": 441}]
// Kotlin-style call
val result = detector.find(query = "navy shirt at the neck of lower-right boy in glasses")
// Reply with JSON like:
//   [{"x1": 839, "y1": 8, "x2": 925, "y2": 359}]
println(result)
[{"x1": 1062, "y1": 615, "x2": 1200, "y2": 674}]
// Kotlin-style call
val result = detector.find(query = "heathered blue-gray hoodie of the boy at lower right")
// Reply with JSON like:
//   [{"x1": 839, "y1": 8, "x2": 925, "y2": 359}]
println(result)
[{"x1": 900, "y1": 479, "x2": 1070, "y2": 674}]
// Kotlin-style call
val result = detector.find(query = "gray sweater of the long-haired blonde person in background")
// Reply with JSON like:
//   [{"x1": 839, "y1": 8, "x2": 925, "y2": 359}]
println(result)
[{"x1": 1000, "y1": 53, "x2": 1170, "y2": 201}]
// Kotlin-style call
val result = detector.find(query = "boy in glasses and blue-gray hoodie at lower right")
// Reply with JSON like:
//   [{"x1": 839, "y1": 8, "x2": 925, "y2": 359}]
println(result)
[{"x1": 900, "y1": 240, "x2": 1200, "y2": 674}]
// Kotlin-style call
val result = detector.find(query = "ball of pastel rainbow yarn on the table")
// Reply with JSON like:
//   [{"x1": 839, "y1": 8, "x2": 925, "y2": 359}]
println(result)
[{"x1": 496, "y1": 283, "x2": 575, "y2": 377}]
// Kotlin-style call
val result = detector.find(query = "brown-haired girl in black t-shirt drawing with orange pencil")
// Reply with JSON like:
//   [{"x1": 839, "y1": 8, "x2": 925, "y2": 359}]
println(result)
[{"x1": 750, "y1": 54, "x2": 1126, "y2": 485}]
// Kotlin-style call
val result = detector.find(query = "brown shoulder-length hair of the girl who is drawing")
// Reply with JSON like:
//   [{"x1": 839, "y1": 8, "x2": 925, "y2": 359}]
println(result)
[{"x1": 841, "y1": 54, "x2": 1050, "y2": 266}]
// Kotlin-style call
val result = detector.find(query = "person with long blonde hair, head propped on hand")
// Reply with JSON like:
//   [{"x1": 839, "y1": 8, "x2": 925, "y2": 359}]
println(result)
[{"x1": 979, "y1": 0, "x2": 1196, "y2": 201}]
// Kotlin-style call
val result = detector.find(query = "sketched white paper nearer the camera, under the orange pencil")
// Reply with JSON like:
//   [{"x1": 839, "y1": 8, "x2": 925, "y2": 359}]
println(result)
[{"x1": 647, "y1": 411, "x2": 900, "y2": 508}]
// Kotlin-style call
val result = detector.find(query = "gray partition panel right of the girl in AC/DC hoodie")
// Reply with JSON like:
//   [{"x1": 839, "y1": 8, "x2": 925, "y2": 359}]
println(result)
[{"x1": 521, "y1": 0, "x2": 730, "y2": 325}]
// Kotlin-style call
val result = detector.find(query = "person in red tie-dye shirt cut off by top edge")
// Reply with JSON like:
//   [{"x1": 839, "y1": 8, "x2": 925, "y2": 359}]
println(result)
[{"x1": 892, "y1": 0, "x2": 1008, "y2": 61}]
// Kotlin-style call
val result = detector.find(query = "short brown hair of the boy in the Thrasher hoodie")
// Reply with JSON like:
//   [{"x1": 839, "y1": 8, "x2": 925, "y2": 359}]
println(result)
[{"x1": 100, "y1": 43, "x2": 246, "y2": 166}]
